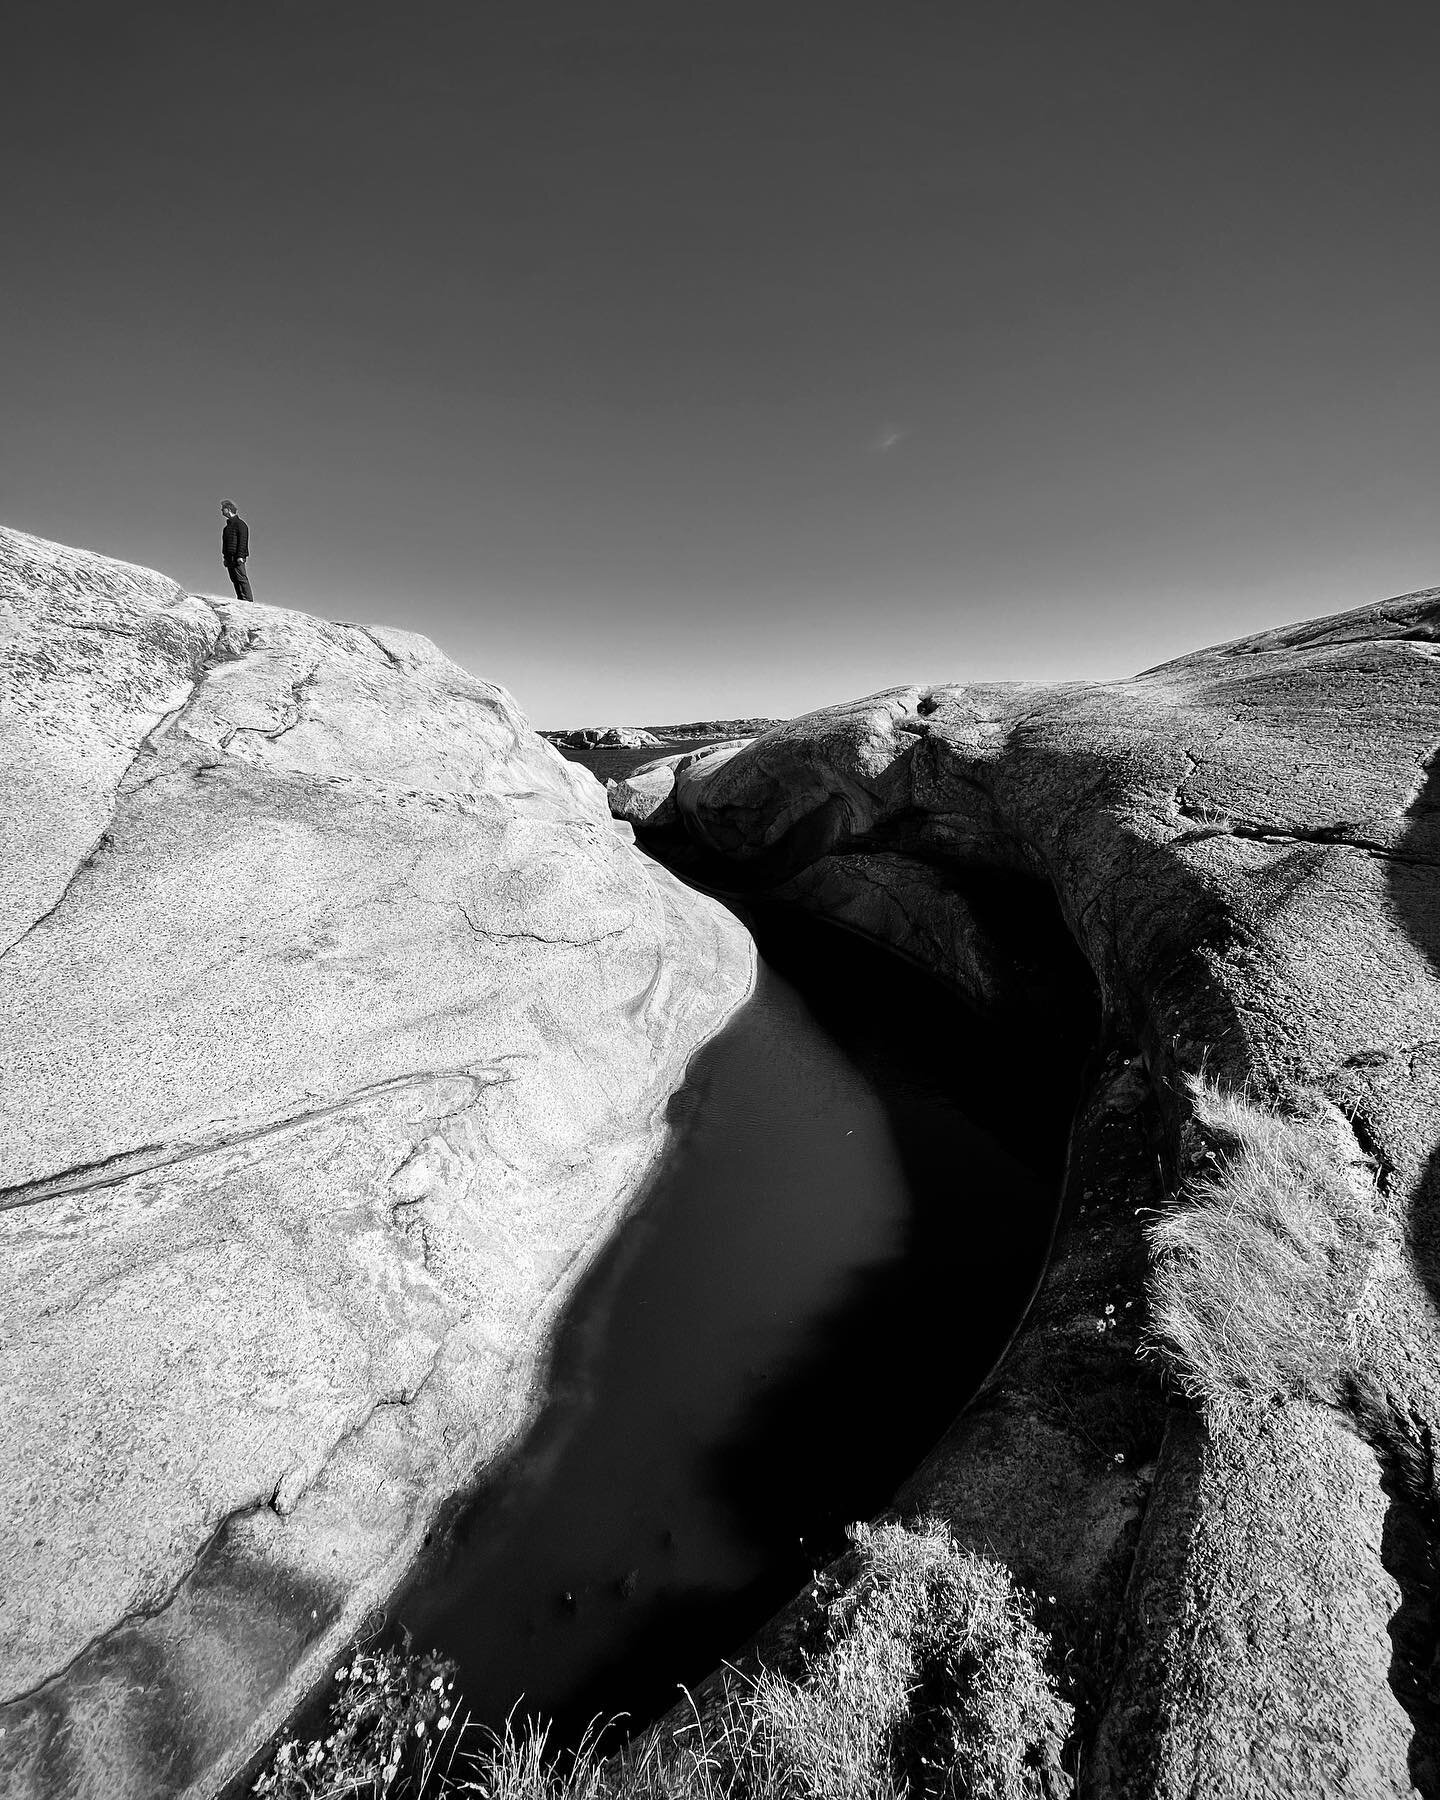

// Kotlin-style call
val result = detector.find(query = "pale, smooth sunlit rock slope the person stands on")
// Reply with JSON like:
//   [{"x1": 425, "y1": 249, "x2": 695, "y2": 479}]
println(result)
[{"x1": 0, "y1": 531, "x2": 752, "y2": 1800}]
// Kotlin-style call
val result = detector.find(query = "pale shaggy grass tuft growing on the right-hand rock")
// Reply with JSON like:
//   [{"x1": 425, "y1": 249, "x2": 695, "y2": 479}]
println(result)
[{"x1": 1147, "y1": 1082, "x2": 1370, "y2": 1415}]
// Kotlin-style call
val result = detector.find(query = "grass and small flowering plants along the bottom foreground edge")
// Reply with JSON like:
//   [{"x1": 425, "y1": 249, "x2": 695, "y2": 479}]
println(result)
[{"x1": 256, "y1": 1523, "x2": 1071, "y2": 1800}]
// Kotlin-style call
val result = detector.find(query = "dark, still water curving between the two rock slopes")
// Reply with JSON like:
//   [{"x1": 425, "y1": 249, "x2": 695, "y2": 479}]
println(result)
[{"x1": 398, "y1": 916, "x2": 1085, "y2": 1732}]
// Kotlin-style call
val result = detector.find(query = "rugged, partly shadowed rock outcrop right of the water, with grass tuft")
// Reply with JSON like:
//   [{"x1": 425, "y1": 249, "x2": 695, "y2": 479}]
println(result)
[{"x1": 610, "y1": 590, "x2": 1440, "y2": 1800}]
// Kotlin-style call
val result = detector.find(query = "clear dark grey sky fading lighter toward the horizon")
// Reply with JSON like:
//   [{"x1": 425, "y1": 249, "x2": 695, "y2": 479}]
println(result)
[{"x1": 0, "y1": 0, "x2": 1440, "y2": 727}]
